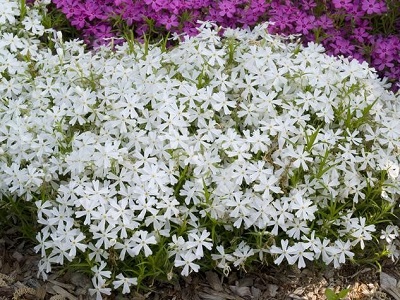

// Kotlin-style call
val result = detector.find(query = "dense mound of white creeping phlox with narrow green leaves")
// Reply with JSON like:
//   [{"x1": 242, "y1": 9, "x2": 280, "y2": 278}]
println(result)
[{"x1": 0, "y1": 0, "x2": 400, "y2": 299}]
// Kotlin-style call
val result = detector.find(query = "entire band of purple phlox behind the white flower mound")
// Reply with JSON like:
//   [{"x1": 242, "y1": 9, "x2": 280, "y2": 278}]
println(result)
[{"x1": 53, "y1": 0, "x2": 400, "y2": 89}]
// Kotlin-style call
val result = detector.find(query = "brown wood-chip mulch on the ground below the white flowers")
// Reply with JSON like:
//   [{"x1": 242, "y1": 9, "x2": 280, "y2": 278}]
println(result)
[{"x1": 0, "y1": 230, "x2": 400, "y2": 300}]
